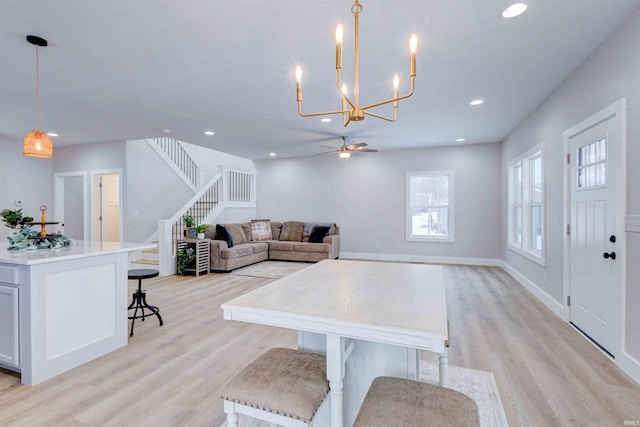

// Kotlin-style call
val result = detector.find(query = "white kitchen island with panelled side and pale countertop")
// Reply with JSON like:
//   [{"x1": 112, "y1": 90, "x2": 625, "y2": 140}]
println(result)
[{"x1": 0, "y1": 241, "x2": 155, "y2": 385}]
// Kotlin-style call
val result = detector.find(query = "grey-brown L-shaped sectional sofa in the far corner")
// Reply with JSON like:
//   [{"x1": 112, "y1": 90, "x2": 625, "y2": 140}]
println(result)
[{"x1": 205, "y1": 221, "x2": 340, "y2": 271}]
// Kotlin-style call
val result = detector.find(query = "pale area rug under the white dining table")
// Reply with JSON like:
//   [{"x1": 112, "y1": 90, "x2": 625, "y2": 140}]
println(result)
[{"x1": 230, "y1": 360, "x2": 509, "y2": 427}]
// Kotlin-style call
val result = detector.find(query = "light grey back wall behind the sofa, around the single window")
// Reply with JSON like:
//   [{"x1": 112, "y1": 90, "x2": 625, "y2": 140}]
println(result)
[{"x1": 255, "y1": 143, "x2": 501, "y2": 259}]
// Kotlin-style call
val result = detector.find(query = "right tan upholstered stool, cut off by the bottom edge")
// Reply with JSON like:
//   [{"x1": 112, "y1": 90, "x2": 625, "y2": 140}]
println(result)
[{"x1": 353, "y1": 377, "x2": 480, "y2": 427}]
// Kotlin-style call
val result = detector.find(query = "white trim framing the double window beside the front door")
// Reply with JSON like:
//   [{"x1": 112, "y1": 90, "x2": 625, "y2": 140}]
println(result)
[{"x1": 507, "y1": 142, "x2": 547, "y2": 266}]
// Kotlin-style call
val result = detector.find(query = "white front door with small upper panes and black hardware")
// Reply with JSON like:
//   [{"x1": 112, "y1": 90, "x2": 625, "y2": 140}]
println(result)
[{"x1": 569, "y1": 105, "x2": 624, "y2": 357}]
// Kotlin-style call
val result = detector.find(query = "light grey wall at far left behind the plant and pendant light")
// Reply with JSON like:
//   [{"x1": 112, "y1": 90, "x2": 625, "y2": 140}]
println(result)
[{"x1": 0, "y1": 139, "x2": 57, "y2": 242}]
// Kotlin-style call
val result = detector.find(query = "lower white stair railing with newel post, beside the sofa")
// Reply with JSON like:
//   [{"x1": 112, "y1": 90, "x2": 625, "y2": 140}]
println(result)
[{"x1": 158, "y1": 167, "x2": 256, "y2": 276}]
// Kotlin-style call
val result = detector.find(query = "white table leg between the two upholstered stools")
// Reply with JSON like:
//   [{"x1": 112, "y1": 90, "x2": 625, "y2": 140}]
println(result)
[{"x1": 327, "y1": 335, "x2": 345, "y2": 427}]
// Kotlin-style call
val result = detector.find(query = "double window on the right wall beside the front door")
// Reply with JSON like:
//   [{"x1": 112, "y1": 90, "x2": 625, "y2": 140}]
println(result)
[{"x1": 508, "y1": 144, "x2": 545, "y2": 265}]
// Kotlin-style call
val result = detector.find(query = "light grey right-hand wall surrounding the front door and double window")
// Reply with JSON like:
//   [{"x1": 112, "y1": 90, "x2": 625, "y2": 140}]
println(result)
[{"x1": 502, "y1": 5, "x2": 640, "y2": 379}]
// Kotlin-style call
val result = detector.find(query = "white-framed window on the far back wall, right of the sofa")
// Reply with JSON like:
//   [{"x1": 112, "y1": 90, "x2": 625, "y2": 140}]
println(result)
[{"x1": 406, "y1": 171, "x2": 454, "y2": 242}]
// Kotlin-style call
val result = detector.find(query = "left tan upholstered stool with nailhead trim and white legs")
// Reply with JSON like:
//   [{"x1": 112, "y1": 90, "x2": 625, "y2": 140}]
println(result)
[{"x1": 221, "y1": 348, "x2": 329, "y2": 427}]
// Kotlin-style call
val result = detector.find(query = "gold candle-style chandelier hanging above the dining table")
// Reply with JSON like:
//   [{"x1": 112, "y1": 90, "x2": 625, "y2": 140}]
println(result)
[{"x1": 296, "y1": 0, "x2": 418, "y2": 127}]
